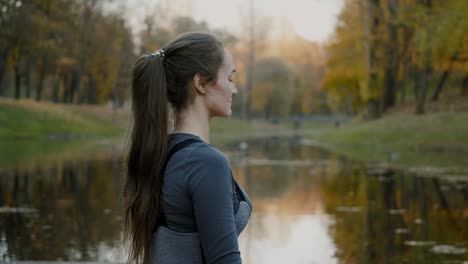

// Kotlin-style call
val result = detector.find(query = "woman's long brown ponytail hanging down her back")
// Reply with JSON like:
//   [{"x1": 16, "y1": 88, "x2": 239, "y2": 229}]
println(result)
[{"x1": 124, "y1": 54, "x2": 169, "y2": 263}]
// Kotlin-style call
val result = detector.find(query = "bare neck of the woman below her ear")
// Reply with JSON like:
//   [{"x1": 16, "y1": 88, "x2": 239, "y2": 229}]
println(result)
[{"x1": 175, "y1": 105, "x2": 210, "y2": 143}]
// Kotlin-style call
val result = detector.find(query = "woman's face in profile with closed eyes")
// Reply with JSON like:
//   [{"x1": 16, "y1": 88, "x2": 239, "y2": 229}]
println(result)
[{"x1": 206, "y1": 49, "x2": 237, "y2": 118}]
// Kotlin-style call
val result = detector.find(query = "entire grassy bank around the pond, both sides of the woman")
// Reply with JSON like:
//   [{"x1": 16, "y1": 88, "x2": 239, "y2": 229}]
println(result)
[{"x1": 0, "y1": 98, "x2": 468, "y2": 167}]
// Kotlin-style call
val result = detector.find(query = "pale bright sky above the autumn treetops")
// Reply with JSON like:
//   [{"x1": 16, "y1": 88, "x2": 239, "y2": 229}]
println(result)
[{"x1": 117, "y1": 0, "x2": 344, "y2": 42}]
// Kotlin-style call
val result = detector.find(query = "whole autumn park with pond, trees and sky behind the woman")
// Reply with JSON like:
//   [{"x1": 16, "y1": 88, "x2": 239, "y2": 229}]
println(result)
[{"x1": 0, "y1": 0, "x2": 468, "y2": 264}]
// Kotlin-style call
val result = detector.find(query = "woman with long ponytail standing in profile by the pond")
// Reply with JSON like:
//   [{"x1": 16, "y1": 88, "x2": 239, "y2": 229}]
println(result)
[{"x1": 124, "y1": 33, "x2": 252, "y2": 264}]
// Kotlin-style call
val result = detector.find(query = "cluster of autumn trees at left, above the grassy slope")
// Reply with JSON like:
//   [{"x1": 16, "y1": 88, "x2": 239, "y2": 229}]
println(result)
[{"x1": 0, "y1": 0, "x2": 133, "y2": 103}]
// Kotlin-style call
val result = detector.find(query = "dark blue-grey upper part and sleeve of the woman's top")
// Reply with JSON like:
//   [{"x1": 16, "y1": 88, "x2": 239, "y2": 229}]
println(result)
[{"x1": 162, "y1": 133, "x2": 252, "y2": 264}]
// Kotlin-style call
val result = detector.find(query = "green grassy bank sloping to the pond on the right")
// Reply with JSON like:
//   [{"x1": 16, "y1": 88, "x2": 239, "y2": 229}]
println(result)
[{"x1": 309, "y1": 112, "x2": 468, "y2": 167}]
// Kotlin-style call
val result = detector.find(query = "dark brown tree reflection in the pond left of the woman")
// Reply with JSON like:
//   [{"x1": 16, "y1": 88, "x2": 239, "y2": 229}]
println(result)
[{"x1": 0, "y1": 159, "x2": 122, "y2": 261}]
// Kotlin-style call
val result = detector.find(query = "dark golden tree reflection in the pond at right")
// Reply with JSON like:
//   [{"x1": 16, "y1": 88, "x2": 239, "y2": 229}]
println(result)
[{"x1": 323, "y1": 158, "x2": 468, "y2": 263}]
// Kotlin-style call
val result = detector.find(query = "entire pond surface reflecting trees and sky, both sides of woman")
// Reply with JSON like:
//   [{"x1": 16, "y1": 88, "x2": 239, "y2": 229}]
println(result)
[{"x1": 0, "y1": 138, "x2": 468, "y2": 264}]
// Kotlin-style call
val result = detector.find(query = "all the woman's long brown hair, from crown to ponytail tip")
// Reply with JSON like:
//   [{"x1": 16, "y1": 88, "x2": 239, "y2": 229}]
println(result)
[{"x1": 124, "y1": 33, "x2": 224, "y2": 263}]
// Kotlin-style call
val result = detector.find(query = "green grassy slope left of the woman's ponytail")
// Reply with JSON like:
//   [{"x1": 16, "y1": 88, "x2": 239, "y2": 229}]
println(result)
[{"x1": 0, "y1": 98, "x2": 125, "y2": 168}]
